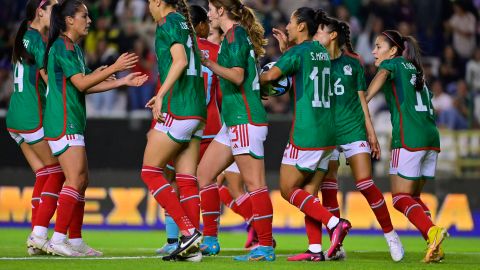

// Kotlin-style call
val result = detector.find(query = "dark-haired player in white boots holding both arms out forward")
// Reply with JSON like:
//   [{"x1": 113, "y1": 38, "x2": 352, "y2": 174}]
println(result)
[{"x1": 43, "y1": 0, "x2": 147, "y2": 256}]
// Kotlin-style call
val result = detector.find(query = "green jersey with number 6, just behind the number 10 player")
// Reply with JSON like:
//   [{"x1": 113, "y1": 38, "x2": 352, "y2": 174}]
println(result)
[{"x1": 331, "y1": 54, "x2": 367, "y2": 145}]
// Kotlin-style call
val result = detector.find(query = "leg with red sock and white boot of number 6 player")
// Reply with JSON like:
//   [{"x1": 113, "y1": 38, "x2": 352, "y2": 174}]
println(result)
[{"x1": 345, "y1": 148, "x2": 405, "y2": 262}]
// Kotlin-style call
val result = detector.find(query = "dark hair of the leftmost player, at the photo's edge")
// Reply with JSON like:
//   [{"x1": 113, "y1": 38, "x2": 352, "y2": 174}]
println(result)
[{"x1": 12, "y1": 0, "x2": 50, "y2": 65}]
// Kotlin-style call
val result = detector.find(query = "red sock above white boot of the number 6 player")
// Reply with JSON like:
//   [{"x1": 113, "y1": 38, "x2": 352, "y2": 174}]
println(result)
[{"x1": 357, "y1": 178, "x2": 393, "y2": 233}]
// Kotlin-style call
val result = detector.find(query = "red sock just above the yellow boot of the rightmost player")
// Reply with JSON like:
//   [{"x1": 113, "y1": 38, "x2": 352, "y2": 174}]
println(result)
[{"x1": 392, "y1": 193, "x2": 433, "y2": 240}]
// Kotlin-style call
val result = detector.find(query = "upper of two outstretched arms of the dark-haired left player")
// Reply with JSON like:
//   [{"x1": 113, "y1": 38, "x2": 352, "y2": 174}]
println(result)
[{"x1": 70, "y1": 53, "x2": 138, "y2": 92}]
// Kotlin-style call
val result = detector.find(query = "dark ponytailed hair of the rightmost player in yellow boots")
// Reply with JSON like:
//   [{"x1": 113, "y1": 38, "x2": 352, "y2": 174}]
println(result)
[{"x1": 382, "y1": 30, "x2": 425, "y2": 91}]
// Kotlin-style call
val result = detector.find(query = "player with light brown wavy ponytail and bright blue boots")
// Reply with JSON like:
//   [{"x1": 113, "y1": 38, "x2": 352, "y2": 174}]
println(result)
[{"x1": 198, "y1": 0, "x2": 275, "y2": 261}]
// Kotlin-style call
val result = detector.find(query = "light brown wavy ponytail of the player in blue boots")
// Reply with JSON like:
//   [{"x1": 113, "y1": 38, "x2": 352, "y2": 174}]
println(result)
[{"x1": 209, "y1": 0, "x2": 268, "y2": 58}]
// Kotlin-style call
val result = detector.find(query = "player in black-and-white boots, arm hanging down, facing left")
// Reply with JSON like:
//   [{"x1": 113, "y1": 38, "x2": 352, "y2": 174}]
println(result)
[{"x1": 141, "y1": 0, "x2": 206, "y2": 260}]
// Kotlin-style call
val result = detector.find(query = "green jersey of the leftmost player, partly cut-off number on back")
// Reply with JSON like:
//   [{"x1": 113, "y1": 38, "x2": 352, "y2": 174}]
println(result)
[{"x1": 7, "y1": 28, "x2": 47, "y2": 133}]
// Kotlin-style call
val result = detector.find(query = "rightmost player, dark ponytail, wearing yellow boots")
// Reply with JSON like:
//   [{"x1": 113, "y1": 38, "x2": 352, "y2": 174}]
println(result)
[{"x1": 367, "y1": 30, "x2": 448, "y2": 262}]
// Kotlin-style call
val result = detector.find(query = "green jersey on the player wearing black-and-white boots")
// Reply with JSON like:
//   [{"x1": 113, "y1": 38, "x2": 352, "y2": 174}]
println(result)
[{"x1": 155, "y1": 12, "x2": 207, "y2": 121}]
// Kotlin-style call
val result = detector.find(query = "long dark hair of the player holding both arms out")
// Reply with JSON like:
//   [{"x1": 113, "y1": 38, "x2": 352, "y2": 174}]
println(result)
[{"x1": 43, "y1": 0, "x2": 85, "y2": 71}]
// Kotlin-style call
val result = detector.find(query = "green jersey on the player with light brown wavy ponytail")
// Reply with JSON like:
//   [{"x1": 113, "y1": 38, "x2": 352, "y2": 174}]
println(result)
[{"x1": 218, "y1": 25, "x2": 267, "y2": 127}]
